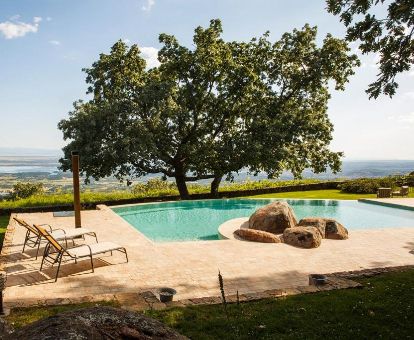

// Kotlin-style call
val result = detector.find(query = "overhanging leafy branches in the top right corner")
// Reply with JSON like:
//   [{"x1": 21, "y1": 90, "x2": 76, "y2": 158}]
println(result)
[{"x1": 327, "y1": 0, "x2": 414, "y2": 98}]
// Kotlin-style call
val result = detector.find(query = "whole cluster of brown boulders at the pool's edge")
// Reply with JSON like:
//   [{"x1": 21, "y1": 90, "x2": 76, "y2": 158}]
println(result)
[{"x1": 234, "y1": 201, "x2": 348, "y2": 248}]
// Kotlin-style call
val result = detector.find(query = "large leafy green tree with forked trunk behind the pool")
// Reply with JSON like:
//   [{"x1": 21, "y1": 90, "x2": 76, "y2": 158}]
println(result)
[{"x1": 59, "y1": 20, "x2": 359, "y2": 198}]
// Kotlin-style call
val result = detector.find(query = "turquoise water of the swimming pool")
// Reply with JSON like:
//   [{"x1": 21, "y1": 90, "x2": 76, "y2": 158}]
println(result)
[{"x1": 112, "y1": 199, "x2": 414, "y2": 242}]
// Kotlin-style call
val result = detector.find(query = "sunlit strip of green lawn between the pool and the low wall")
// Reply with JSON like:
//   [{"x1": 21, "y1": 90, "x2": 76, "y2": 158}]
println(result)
[{"x1": 247, "y1": 189, "x2": 414, "y2": 200}]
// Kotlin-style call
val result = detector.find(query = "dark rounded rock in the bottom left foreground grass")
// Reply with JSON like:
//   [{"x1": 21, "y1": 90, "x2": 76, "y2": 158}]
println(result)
[{"x1": 4, "y1": 307, "x2": 187, "y2": 340}]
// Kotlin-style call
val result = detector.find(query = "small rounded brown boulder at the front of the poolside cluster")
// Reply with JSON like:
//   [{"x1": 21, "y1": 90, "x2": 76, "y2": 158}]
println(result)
[{"x1": 283, "y1": 227, "x2": 322, "y2": 248}]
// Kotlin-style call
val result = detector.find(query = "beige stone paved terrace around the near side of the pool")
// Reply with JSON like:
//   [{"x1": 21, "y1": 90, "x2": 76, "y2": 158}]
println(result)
[{"x1": 2, "y1": 208, "x2": 414, "y2": 307}]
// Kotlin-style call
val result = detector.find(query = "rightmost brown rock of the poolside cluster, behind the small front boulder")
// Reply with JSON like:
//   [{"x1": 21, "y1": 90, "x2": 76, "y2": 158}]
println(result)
[{"x1": 298, "y1": 217, "x2": 348, "y2": 240}]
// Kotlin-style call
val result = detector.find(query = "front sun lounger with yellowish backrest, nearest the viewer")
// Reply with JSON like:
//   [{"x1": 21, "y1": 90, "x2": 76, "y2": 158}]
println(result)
[{"x1": 33, "y1": 224, "x2": 129, "y2": 282}]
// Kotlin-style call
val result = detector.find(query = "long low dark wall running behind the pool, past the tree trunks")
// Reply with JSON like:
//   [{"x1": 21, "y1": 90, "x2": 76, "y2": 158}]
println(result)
[{"x1": 0, "y1": 181, "x2": 343, "y2": 215}]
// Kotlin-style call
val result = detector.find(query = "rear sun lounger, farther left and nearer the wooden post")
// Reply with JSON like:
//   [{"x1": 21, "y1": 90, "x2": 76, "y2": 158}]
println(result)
[{"x1": 13, "y1": 217, "x2": 98, "y2": 260}]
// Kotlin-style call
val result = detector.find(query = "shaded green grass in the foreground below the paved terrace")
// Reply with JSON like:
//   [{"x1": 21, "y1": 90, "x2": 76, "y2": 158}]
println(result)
[{"x1": 7, "y1": 270, "x2": 414, "y2": 339}]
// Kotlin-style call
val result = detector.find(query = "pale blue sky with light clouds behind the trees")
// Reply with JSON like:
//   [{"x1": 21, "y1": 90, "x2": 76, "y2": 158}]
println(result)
[{"x1": 0, "y1": 0, "x2": 414, "y2": 159}]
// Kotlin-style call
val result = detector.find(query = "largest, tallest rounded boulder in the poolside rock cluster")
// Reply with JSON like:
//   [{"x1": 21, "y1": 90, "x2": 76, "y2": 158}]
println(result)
[{"x1": 249, "y1": 201, "x2": 297, "y2": 234}]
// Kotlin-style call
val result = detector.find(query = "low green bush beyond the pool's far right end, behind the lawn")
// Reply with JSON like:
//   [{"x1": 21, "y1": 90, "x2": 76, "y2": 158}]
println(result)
[{"x1": 340, "y1": 177, "x2": 398, "y2": 194}]
